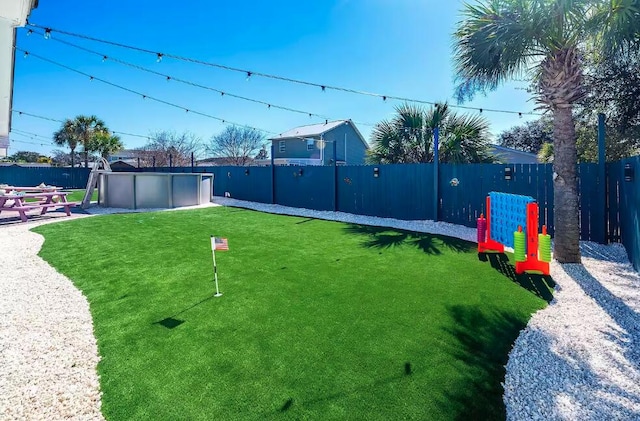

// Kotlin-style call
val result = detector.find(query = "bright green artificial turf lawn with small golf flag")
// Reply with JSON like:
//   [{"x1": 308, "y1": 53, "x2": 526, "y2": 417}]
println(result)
[{"x1": 34, "y1": 207, "x2": 550, "y2": 420}]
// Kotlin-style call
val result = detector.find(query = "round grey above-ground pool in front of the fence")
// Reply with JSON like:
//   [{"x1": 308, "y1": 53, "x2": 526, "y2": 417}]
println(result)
[{"x1": 98, "y1": 172, "x2": 213, "y2": 209}]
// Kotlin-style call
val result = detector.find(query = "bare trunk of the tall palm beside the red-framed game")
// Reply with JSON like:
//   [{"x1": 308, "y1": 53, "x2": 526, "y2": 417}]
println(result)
[{"x1": 553, "y1": 108, "x2": 580, "y2": 263}]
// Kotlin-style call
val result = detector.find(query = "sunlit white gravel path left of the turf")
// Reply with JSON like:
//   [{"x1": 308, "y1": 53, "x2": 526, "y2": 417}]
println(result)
[{"x1": 0, "y1": 212, "x2": 103, "y2": 420}]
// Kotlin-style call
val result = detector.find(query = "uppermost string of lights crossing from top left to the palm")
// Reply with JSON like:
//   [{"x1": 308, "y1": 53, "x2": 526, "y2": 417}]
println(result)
[{"x1": 22, "y1": 23, "x2": 541, "y2": 115}]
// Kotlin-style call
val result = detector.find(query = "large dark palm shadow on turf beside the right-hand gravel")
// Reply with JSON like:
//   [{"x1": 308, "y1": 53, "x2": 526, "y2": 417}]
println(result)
[{"x1": 440, "y1": 305, "x2": 526, "y2": 420}]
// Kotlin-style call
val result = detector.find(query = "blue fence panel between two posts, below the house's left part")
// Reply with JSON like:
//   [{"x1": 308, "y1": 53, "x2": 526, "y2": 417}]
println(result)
[{"x1": 275, "y1": 165, "x2": 335, "y2": 211}]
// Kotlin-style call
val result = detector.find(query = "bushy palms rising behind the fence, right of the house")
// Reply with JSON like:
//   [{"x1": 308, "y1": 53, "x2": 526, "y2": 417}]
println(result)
[{"x1": 367, "y1": 104, "x2": 492, "y2": 164}]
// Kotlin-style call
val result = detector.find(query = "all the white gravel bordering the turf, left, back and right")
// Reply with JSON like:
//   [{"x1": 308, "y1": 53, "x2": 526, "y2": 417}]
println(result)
[{"x1": 0, "y1": 197, "x2": 640, "y2": 420}]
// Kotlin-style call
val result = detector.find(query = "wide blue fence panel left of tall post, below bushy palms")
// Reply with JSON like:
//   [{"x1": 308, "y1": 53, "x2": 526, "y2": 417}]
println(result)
[{"x1": 337, "y1": 164, "x2": 435, "y2": 220}]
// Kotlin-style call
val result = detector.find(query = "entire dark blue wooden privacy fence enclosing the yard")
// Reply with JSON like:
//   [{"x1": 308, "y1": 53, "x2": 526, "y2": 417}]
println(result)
[{"x1": 0, "y1": 156, "x2": 640, "y2": 269}]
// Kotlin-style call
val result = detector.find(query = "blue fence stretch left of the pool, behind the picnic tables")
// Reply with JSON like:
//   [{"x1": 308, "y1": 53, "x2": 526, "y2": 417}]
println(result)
[{"x1": 0, "y1": 166, "x2": 91, "y2": 189}]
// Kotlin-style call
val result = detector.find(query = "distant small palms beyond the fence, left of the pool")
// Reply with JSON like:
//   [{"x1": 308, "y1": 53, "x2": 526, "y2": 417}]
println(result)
[{"x1": 53, "y1": 115, "x2": 109, "y2": 167}]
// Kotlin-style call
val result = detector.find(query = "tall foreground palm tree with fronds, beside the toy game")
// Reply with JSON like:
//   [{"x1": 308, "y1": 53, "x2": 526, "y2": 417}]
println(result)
[{"x1": 454, "y1": 0, "x2": 640, "y2": 263}]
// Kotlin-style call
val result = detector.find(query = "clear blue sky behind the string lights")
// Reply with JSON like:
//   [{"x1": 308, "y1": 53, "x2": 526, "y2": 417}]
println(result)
[{"x1": 10, "y1": 0, "x2": 534, "y2": 153}]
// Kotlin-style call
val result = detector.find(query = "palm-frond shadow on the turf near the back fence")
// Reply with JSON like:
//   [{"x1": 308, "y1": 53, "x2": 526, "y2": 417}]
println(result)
[{"x1": 345, "y1": 224, "x2": 473, "y2": 255}]
